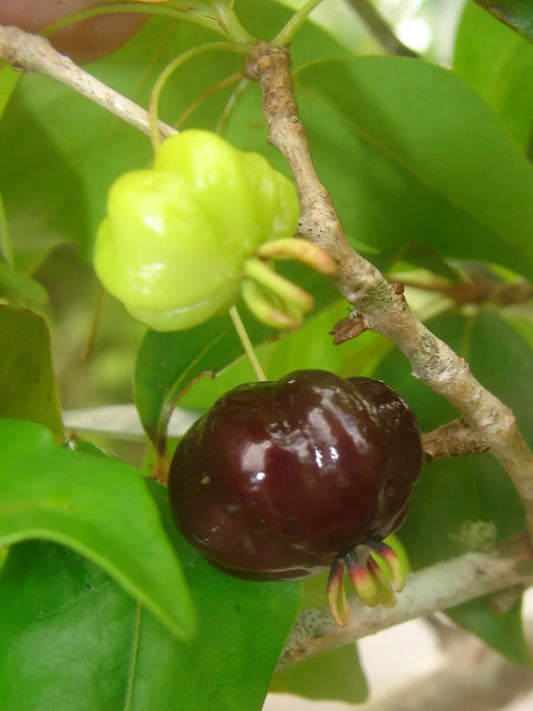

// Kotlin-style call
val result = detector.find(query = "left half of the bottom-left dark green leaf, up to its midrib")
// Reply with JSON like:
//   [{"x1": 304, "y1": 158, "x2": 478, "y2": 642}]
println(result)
[{"x1": 0, "y1": 541, "x2": 137, "y2": 711}]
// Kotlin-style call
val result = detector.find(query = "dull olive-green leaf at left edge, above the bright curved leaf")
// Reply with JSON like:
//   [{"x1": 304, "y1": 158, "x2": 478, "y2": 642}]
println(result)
[{"x1": 0, "y1": 304, "x2": 63, "y2": 437}]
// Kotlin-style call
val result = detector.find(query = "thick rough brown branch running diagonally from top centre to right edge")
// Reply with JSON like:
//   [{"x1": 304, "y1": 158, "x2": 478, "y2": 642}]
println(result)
[{"x1": 246, "y1": 43, "x2": 533, "y2": 531}]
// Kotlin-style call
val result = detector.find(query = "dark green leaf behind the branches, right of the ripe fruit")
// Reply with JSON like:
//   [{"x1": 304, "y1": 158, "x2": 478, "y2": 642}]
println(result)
[{"x1": 376, "y1": 309, "x2": 533, "y2": 661}]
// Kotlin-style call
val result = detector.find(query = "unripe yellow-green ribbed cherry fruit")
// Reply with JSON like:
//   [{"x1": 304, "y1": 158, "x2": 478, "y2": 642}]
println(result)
[{"x1": 94, "y1": 129, "x2": 306, "y2": 331}]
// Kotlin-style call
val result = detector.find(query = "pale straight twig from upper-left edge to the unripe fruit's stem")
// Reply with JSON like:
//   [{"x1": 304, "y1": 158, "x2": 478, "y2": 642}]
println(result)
[{"x1": 0, "y1": 25, "x2": 176, "y2": 137}]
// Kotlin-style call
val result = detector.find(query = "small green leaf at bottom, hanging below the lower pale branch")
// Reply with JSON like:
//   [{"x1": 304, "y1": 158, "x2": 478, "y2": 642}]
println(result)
[{"x1": 271, "y1": 644, "x2": 368, "y2": 704}]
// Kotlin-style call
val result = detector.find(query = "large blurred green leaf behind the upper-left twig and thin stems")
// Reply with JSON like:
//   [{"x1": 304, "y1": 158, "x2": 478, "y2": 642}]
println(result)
[{"x1": 0, "y1": 0, "x2": 343, "y2": 268}]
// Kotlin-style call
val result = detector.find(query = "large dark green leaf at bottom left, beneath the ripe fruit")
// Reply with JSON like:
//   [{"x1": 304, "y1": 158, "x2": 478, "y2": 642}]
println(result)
[{"x1": 0, "y1": 486, "x2": 299, "y2": 711}]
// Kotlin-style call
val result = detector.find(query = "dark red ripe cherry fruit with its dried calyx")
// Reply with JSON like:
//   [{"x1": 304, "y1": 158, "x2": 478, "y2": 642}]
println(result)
[{"x1": 169, "y1": 370, "x2": 422, "y2": 624}]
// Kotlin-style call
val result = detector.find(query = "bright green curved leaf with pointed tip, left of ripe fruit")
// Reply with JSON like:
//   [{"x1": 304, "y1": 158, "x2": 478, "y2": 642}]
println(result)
[{"x1": 0, "y1": 419, "x2": 195, "y2": 637}]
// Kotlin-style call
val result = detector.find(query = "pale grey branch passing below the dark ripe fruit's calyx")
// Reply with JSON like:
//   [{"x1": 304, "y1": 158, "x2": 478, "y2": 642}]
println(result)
[{"x1": 279, "y1": 536, "x2": 533, "y2": 670}]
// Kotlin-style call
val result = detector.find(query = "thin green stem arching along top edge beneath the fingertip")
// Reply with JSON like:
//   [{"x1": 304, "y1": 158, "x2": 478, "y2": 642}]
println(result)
[{"x1": 40, "y1": 3, "x2": 226, "y2": 37}]
